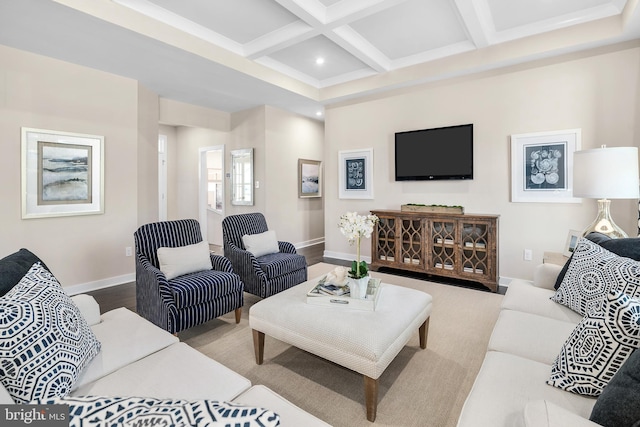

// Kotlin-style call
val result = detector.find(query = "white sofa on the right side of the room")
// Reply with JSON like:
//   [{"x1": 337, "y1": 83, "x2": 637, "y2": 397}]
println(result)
[{"x1": 458, "y1": 264, "x2": 598, "y2": 427}]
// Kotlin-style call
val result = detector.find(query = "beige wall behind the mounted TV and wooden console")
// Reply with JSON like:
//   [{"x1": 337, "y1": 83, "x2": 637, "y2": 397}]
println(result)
[{"x1": 324, "y1": 44, "x2": 640, "y2": 284}]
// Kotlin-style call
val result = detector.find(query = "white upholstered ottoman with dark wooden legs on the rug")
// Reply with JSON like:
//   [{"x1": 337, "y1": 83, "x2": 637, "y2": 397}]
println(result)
[{"x1": 249, "y1": 279, "x2": 432, "y2": 421}]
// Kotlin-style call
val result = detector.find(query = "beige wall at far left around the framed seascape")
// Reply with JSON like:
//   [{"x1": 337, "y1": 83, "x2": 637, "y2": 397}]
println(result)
[{"x1": 0, "y1": 46, "x2": 139, "y2": 286}]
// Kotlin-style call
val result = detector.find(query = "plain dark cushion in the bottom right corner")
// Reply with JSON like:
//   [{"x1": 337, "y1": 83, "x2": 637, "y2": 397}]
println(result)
[{"x1": 589, "y1": 350, "x2": 640, "y2": 427}]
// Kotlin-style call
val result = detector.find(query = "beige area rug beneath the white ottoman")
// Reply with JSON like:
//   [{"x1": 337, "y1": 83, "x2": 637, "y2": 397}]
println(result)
[{"x1": 180, "y1": 263, "x2": 502, "y2": 427}]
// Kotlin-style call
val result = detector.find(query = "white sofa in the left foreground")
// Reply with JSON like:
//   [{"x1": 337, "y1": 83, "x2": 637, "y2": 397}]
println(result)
[{"x1": 0, "y1": 295, "x2": 328, "y2": 427}]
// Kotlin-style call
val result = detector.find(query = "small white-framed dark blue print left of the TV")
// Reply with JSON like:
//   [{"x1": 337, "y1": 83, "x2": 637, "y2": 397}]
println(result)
[{"x1": 338, "y1": 148, "x2": 373, "y2": 199}]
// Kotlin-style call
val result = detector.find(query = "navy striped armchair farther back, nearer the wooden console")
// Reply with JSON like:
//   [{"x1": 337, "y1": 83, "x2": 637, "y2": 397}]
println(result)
[{"x1": 222, "y1": 213, "x2": 307, "y2": 298}]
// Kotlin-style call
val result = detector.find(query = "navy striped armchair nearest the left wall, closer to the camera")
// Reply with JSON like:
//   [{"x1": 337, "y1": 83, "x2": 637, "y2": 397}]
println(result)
[{"x1": 133, "y1": 219, "x2": 244, "y2": 334}]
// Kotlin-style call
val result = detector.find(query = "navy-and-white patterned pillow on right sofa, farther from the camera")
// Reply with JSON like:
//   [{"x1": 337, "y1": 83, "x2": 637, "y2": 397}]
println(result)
[{"x1": 551, "y1": 238, "x2": 640, "y2": 316}]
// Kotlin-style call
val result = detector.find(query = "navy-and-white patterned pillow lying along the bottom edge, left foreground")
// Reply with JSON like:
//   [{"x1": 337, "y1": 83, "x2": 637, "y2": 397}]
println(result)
[{"x1": 38, "y1": 396, "x2": 280, "y2": 427}]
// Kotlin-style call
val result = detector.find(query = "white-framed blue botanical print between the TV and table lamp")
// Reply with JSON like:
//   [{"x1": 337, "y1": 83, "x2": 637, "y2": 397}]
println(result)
[{"x1": 511, "y1": 129, "x2": 582, "y2": 203}]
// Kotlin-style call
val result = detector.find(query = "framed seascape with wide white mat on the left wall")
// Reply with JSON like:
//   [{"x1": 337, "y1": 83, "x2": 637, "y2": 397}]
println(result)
[{"x1": 22, "y1": 128, "x2": 104, "y2": 219}]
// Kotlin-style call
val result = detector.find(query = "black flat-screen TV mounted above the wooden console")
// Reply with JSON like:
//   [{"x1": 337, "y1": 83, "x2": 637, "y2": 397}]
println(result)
[{"x1": 395, "y1": 124, "x2": 473, "y2": 181}]
